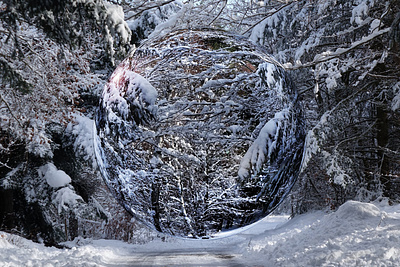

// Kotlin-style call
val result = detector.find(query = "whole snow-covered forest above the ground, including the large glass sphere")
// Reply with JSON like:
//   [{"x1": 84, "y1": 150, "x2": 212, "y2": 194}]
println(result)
[{"x1": 0, "y1": 0, "x2": 400, "y2": 245}]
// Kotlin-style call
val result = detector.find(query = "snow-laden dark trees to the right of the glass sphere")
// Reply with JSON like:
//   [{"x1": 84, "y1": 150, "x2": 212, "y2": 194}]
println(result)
[{"x1": 250, "y1": 0, "x2": 400, "y2": 210}]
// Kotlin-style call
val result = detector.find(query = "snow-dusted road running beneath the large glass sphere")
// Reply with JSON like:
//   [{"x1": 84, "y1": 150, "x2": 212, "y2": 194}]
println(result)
[{"x1": 102, "y1": 216, "x2": 288, "y2": 267}]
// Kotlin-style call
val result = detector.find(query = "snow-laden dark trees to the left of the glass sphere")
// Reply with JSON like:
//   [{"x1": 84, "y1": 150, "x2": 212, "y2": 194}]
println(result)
[{"x1": 0, "y1": 0, "x2": 151, "y2": 245}]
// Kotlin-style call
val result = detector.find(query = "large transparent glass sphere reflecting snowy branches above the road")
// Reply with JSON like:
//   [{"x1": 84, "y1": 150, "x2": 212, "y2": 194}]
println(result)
[{"x1": 95, "y1": 30, "x2": 304, "y2": 237}]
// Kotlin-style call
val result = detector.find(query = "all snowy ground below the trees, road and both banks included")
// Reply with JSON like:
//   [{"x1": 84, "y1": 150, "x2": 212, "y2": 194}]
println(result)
[{"x1": 0, "y1": 201, "x2": 400, "y2": 266}]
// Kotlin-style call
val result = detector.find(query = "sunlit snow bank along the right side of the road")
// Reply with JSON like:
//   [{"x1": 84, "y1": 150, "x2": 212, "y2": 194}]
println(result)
[{"x1": 246, "y1": 201, "x2": 400, "y2": 266}]
